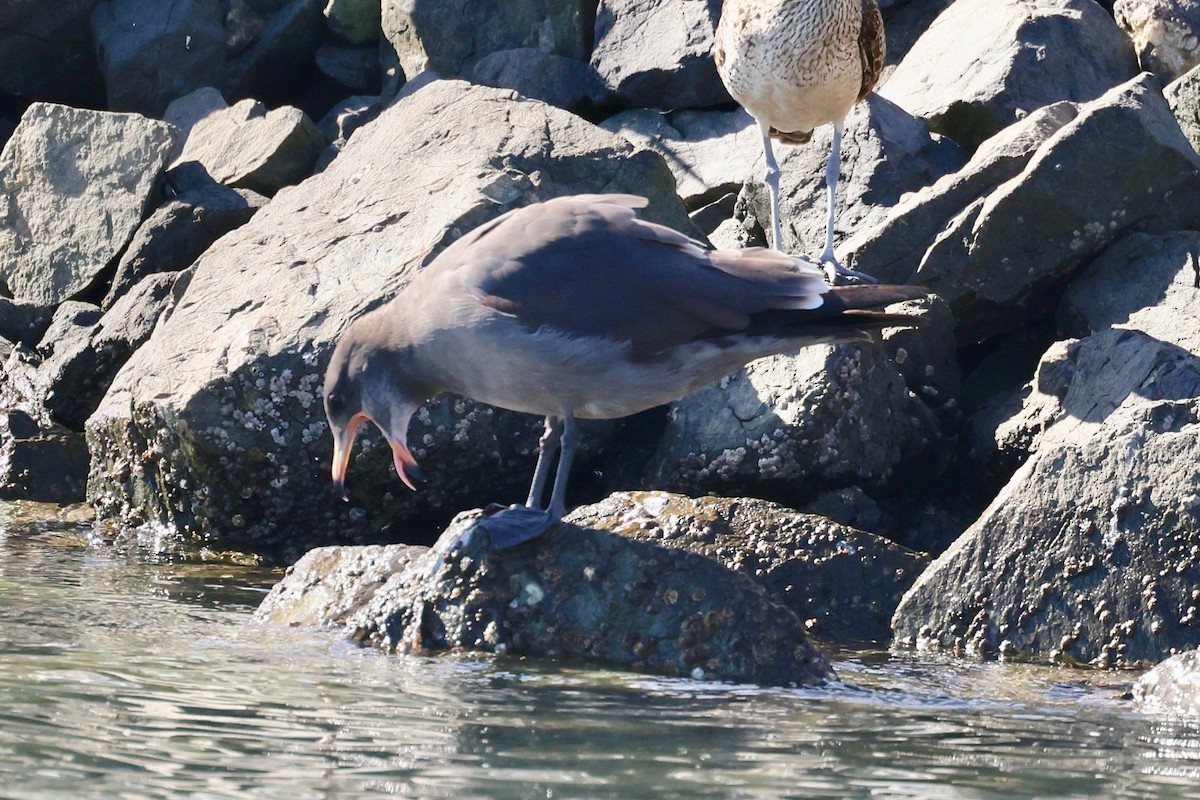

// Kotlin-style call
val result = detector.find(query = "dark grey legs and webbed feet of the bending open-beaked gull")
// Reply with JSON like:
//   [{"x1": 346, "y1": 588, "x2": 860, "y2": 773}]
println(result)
[{"x1": 475, "y1": 411, "x2": 578, "y2": 551}]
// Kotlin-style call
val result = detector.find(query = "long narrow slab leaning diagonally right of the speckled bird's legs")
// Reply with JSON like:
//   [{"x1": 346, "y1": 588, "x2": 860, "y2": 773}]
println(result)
[{"x1": 840, "y1": 102, "x2": 1079, "y2": 283}]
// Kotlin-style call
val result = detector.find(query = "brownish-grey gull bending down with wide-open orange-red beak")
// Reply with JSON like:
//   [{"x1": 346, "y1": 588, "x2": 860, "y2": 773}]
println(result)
[{"x1": 325, "y1": 194, "x2": 925, "y2": 541}]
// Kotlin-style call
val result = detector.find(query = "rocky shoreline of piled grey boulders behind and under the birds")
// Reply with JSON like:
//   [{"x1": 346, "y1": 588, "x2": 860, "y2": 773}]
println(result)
[{"x1": 0, "y1": 0, "x2": 1200, "y2": 695}]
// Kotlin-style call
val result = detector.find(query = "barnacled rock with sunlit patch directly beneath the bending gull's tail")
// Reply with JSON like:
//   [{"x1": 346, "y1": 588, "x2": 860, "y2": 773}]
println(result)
[{"x1": 646, "y1": 326, "x2": 937, "y2": 500}]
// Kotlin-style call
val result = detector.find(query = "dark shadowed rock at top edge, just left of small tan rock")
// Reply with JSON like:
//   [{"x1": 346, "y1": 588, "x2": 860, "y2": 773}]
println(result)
[{"x1": 221, "y1": 0, "x2": 326, "y2": 108}]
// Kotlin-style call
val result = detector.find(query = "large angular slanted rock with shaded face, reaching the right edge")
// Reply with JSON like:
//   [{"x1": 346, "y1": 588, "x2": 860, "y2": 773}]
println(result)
[{"x1": 853, "y1": 76, "x2": 1200, "y2": 344}]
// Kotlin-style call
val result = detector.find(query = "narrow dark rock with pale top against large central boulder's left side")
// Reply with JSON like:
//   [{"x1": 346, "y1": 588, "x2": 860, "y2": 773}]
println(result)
[{"x1": 38, "y1": 272, "x2": 178, "y2": 432}]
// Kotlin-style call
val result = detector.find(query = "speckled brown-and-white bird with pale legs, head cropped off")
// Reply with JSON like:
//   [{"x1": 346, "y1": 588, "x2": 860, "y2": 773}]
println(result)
[{"x1": 713, "y1": 0, "x2": 884, "y2": 282}]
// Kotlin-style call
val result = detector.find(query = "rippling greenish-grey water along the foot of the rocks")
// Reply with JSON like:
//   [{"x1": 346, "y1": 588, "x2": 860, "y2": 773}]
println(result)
[{"x1": 0, "y1": 509, "x2": 1200, "y2": 800}]
